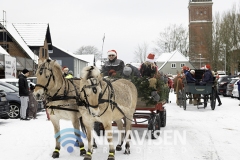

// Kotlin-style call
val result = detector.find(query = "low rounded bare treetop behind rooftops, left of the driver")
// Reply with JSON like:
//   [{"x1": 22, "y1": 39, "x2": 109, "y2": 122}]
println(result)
[{"x1": 74, "y1": 46, "x2": 101, "y2": 60}]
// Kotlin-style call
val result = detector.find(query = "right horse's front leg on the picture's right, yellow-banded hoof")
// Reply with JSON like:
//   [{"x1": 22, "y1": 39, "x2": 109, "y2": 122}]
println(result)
[{"x1": 104, "y1": 121, "x2": 115, "y2": 160}]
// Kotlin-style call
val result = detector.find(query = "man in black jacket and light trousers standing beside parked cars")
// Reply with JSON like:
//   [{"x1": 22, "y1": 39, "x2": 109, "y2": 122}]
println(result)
[{"x1": 18, "y1": 69, "x2": 30, "y2": 120}]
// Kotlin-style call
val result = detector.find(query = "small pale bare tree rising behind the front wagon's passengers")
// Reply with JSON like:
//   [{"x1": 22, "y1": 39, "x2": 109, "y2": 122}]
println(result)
[{"x1": 134, "y1": 42, "x2": 148, "y2": 63}]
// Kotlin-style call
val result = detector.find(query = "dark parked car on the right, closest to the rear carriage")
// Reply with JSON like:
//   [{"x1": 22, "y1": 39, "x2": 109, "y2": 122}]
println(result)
[{"x1": 217, "y1": 76, "x2": 236, "y2": 96}]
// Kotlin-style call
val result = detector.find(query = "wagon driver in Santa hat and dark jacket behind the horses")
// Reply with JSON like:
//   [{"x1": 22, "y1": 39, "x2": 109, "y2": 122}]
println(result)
[{"x1": 102, "y1": 50, "x2": 125, "y2": 76}]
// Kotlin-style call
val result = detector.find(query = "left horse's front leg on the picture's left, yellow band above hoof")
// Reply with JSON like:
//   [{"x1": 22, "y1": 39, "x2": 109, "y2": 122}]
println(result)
[{"x1": 50, "y1": 117, "x2": 61, "y2": 158}]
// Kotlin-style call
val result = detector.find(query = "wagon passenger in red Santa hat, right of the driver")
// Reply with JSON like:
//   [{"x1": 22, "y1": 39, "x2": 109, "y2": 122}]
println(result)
[{"x1": 140, "y1": 53, "x2": 158, "y2": 78}]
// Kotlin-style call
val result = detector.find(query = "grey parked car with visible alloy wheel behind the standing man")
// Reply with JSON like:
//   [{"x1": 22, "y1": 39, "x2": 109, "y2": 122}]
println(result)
[{"x1": 0, "y1": 82, "x2": 43, "y2": 118}]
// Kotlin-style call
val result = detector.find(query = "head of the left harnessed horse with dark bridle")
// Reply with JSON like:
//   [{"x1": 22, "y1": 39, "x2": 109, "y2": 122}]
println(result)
[{"x1": 33, "y1": 59, "x2": 63, "y2": 100}]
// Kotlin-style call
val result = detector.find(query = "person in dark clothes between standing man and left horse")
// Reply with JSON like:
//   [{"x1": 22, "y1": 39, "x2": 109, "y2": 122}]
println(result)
[{"x1": 28, "y1": 84, "x2": 38, "y2": 119}]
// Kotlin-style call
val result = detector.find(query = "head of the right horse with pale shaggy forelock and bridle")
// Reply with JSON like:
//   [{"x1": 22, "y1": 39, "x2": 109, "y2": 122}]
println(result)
[{"x1": 80, "y1": 66, "x2": 102, "y2": 116}]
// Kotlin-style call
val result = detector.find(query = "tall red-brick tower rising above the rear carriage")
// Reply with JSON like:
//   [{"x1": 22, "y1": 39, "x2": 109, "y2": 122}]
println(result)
[{"x1": 188, "y1": 0, "x2": 213, "y2": 69}]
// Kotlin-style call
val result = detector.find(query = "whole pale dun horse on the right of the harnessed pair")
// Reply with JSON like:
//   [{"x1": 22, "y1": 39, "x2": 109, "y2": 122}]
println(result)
[{"x1": 79, "y1": 66, "x2": 137, "y2": 160}]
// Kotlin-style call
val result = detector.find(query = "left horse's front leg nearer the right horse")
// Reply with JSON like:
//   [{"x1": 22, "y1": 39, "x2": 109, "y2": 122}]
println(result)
[{"x1": 72, "y1": 117, "x2": 86, "y2": 156}]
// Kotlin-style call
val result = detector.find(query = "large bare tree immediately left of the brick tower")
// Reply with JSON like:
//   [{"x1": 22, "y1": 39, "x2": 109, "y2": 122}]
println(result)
[{"x1": 154, "y1": 24, "x2": 188, "y2": 54}]
